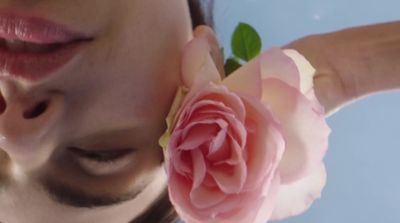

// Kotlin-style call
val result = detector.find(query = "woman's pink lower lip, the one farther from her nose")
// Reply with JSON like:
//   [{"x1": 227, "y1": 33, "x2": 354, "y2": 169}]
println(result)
[{"x1": 0, "y1": 11, "x2": 90, "y2": 44}]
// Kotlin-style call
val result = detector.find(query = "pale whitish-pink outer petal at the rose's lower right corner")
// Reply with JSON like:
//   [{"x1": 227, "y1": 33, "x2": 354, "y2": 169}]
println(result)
[{"x1": 271, "y1": 164, "x2": 326, "y2": 220}]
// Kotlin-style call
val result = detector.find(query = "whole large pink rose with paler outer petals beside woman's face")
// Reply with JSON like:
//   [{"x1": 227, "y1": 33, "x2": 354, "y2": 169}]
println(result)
[{"x1": 160, "y1": 34, "x2": 330, "y2": 223}]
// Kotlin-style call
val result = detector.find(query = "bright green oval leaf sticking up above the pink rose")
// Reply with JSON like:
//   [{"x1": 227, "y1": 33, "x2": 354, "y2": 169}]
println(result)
[{"x1": 231, "y1": 23, "x2": 262, "y2": 62}]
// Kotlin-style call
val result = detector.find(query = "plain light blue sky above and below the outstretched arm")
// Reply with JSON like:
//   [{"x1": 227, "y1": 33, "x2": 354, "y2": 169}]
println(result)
[{"x1": 215, "y1": 0, "x2": 400, "y2": 223}]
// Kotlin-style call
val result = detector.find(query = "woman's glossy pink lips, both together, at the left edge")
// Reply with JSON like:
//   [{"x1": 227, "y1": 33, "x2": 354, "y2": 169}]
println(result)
[{"x1": 0, "y1": 11, "x2": 92, "y2": 81}]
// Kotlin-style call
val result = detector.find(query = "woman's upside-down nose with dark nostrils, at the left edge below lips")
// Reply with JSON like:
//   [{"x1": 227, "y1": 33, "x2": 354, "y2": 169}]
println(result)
[{"x1": 0, "y1": 90, "x2": 64, "y2": 167}]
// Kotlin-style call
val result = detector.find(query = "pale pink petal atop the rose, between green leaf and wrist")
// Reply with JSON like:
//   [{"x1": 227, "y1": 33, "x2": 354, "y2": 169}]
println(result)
[{"x1": 260, "y1": 48, "x2": 300, "y2": 89}]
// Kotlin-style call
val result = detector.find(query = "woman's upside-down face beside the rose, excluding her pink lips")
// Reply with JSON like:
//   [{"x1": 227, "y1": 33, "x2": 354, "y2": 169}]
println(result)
[{"x1": 0, "y1": 0, "x2": 192, "y2": 223}]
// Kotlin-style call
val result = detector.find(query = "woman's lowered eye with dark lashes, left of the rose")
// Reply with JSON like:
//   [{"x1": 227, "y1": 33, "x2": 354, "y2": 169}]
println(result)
[{"x1": 68, "y1": 147, "x2": 135, "y2": 175}]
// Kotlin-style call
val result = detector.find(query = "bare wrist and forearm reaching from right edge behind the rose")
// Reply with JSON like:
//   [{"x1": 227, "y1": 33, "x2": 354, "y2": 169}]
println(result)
[{"x1": 284, "y1": 22, "x2": 400, "y2": 115}]
